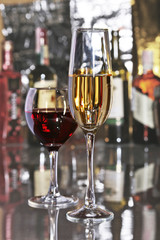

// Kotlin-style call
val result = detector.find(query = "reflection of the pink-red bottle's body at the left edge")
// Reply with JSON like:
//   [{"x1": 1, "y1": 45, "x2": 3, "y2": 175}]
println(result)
[{"x1": 0, "y1": 145, "x2": 22, "y2": 204}]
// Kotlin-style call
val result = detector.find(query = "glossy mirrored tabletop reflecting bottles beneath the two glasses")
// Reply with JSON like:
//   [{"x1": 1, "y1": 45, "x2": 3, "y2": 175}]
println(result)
[{"x1": 0, "y1": 136, "x2": 160, "y2": 240}]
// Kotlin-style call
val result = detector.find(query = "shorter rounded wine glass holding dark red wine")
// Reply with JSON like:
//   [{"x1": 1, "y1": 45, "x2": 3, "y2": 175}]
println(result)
[{"x1": 25, "y1": 87, "x2": 78, "y2": 208}]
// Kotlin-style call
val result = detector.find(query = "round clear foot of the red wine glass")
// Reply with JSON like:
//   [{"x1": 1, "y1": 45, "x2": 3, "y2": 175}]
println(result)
[{"x1": 28, "y1": 195, "x2": 79, "y2": 209}]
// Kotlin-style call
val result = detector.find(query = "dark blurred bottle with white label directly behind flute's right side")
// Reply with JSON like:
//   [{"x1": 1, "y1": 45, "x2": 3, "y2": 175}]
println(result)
[{"x1": 105, "y1": 31, "x2": 130, "y2": 143}]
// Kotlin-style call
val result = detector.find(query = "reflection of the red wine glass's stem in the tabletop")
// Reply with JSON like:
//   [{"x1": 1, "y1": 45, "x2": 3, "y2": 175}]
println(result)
[{"x1": 48, "y1": 208, "x2": 59, "y2": 240}]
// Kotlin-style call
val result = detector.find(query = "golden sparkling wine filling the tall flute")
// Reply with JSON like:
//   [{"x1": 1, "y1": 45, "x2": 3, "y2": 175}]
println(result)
[{"x1": 69, "y1": 74, "x2": 112, "y2": 132}]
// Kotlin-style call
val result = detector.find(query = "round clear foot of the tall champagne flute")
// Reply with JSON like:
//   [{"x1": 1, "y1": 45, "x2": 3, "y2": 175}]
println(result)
[{"x1": 66, "y1": 206, "x2": 114, "y2": 224}]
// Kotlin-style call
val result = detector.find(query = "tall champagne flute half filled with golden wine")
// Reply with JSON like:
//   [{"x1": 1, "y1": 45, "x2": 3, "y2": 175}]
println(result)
[{"x1": 66, "y1": 28, "x2": 113, "y2": 223}]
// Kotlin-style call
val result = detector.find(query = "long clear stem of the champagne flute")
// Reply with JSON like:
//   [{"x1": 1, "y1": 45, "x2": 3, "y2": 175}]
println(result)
[{"x1": 85, "y1": 133, "x2": 95, "y2": 208}]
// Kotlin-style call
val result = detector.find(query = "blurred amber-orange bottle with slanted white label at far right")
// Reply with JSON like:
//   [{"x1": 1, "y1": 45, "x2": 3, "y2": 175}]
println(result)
[{"x1": 132, "y1": 50, "x2": 160, "y2": 144}]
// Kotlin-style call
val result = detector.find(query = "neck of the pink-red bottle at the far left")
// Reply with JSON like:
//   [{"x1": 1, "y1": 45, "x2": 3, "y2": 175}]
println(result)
[{"x1": 2, "y1": 41, "x2": 13, "y2": 71}]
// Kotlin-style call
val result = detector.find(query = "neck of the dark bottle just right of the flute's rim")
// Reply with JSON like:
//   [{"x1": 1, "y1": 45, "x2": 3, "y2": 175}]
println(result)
[{"x1": 111, "y1": 31, "x2": 120, "y2": 61}]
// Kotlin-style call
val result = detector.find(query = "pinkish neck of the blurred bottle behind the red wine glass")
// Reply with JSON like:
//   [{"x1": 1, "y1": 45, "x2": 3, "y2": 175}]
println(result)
[{"x1": 36, "y1": 28, "x2": 50, "y2": 66}]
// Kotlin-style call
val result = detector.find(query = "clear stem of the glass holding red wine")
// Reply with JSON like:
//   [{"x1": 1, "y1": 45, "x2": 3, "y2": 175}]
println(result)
[{"x1": 48, "y1": 151, "x2": 60, "y2": 197}]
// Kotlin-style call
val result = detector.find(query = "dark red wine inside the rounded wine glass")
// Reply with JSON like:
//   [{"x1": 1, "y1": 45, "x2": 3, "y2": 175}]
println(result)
[{"x1": 25, "y1": 109, "x2": 77, "y2": 151}]
